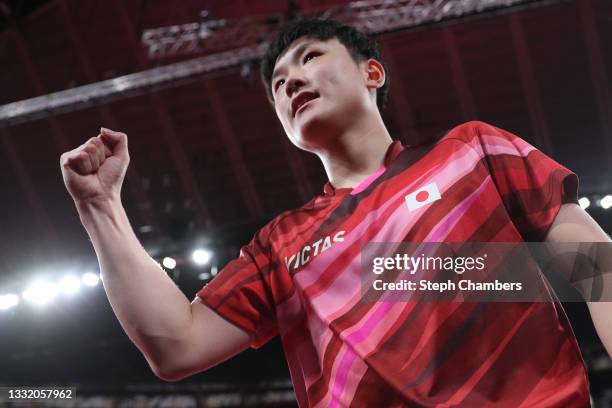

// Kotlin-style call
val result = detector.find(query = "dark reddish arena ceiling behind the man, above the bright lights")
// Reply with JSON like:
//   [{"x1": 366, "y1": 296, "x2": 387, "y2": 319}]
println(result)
[{"x1": 0, "y1": 0, "x2": 612, "y2": 386}]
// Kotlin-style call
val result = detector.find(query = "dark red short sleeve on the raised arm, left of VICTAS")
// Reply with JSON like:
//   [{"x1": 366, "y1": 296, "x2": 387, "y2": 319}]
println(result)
[{"x1": 196, "y1": 226, "x2": 278, "y2": 348}]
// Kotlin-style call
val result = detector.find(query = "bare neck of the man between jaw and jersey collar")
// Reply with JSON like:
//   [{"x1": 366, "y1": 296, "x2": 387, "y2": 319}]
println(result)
[{"x1": 315, "y1": 112, "x2": 393, "y2": 188}]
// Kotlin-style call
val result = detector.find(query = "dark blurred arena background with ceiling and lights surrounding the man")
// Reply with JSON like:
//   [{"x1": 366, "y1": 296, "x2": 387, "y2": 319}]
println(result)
[{"x1": 0, "y1": 0, "x2": 612, "y2": 407}]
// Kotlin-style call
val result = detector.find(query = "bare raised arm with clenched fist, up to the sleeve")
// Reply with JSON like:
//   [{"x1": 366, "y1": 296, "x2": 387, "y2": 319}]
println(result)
[{"x1": 60, "y1": 129, "x2": 250, "y2": 381}]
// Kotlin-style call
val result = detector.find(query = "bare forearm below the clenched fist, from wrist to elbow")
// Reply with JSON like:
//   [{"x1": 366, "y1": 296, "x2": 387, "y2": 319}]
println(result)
[{"x1": 77, "y1": 197, "x2": 191, "y2": 363}]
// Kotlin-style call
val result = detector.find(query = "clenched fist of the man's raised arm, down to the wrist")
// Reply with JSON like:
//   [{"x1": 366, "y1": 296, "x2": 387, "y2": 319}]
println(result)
[{"x1": 60, "y1": 128, "x2": 130, "y2": 203}]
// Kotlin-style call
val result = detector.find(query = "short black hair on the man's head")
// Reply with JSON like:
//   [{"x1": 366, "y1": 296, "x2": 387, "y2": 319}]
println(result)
[{"x1": 260, "y1": 19, "x2": 390, "y2": 112}]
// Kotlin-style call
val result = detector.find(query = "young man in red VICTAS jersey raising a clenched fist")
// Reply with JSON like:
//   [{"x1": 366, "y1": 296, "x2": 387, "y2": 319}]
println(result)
[{"x1": 61, "y1": 20, "x2": 612, "y2": 407}]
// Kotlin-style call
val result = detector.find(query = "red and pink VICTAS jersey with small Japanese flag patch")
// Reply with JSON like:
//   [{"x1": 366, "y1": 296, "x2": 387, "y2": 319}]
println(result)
[{"x1": 197, "y1": 122, "x2": 589, "y2": 407}]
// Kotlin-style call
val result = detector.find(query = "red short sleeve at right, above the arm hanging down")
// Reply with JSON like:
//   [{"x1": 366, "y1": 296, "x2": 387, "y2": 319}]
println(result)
[{"x1": 470, "y1": 122, "x2": 578, "y2": 242}]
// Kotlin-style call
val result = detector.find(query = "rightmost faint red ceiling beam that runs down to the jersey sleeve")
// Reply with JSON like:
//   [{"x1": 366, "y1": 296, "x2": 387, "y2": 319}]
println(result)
[{"x1": 507, "y1": 13, "x2": 555, "y2": 156}]
